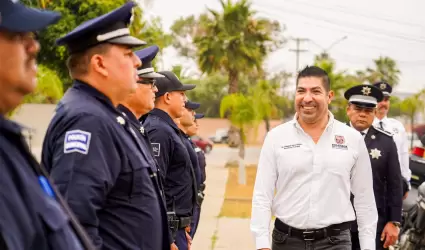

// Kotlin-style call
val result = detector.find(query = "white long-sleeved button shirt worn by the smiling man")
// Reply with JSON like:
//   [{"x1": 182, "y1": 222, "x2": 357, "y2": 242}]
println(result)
[{"x1": 251, "y1": 112, "x2": 378, "y2": 250}]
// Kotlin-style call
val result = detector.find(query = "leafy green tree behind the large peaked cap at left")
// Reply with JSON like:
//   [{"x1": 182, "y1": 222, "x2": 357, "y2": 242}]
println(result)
[{"x1": 22, "y1": 0, "x2": 171, "y2": 89}]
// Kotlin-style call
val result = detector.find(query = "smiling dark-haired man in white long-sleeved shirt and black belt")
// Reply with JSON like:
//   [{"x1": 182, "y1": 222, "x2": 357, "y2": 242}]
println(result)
[{"x1": 251, "y1": 66, "x2": 378, "y2": 250}]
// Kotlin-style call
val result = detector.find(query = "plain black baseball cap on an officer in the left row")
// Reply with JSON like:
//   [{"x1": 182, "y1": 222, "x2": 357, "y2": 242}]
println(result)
[{"x1": 155, "y1": 71, "x2": 196, "y2": 97}]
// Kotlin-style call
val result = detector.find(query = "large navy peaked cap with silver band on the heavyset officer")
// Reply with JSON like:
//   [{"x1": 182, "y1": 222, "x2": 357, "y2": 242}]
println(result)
[{"x1": 56, "y1": 1, "x2": 146, "y2": 54}]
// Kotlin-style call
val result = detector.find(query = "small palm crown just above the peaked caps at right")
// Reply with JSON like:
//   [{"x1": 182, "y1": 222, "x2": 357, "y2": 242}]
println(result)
[{"x1": 366, "y1": 56, "x2": 401, "y2": 87}]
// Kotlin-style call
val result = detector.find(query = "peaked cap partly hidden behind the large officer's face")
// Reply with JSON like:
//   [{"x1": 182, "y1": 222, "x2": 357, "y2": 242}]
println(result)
[{"x1": 135, "y1": 45, "x2": 165, "y2": 78}]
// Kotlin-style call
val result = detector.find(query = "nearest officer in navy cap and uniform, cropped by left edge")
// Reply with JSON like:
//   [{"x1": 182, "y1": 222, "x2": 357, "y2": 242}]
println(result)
[{"x1": 0, "y1": 0, "x2": 94, "y2": 250}]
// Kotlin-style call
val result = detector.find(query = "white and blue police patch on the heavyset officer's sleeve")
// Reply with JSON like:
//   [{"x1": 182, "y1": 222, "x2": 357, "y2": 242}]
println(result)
[{"x1": 63, "y1": 130, "x2": 91, "y2": 154}]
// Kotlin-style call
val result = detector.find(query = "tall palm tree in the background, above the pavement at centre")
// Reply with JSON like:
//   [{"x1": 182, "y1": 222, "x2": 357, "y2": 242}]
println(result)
[{"x1": 194, "y1": 0, "x2": 283, "y2": 94}]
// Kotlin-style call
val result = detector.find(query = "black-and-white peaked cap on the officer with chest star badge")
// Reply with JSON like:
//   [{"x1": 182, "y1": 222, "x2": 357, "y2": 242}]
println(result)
[{"x1": 344, "y1": 84, "x2": 384, "y2": 108}]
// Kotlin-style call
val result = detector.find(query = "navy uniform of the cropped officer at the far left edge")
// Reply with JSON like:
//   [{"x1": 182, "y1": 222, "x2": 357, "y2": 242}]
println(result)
[{"x1": 0, "y1": 116, "x2": 83, "y2": 250}]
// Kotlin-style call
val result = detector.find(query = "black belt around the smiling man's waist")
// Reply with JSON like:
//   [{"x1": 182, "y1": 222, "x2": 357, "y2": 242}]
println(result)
[{"x1": 274, "y1": 219, "x2": 351, "y2": 241}]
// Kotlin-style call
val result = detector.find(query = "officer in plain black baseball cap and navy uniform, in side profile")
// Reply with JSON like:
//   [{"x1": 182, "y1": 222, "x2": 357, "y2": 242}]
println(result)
[{"x1": 143, "y1": 71, "x2": 197, "y2": 250}]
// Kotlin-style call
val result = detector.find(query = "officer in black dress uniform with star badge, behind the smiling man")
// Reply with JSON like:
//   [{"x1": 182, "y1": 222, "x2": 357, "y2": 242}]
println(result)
[{"x1": 344, "y1": 85, "x2": 403, "y2": 249}]
